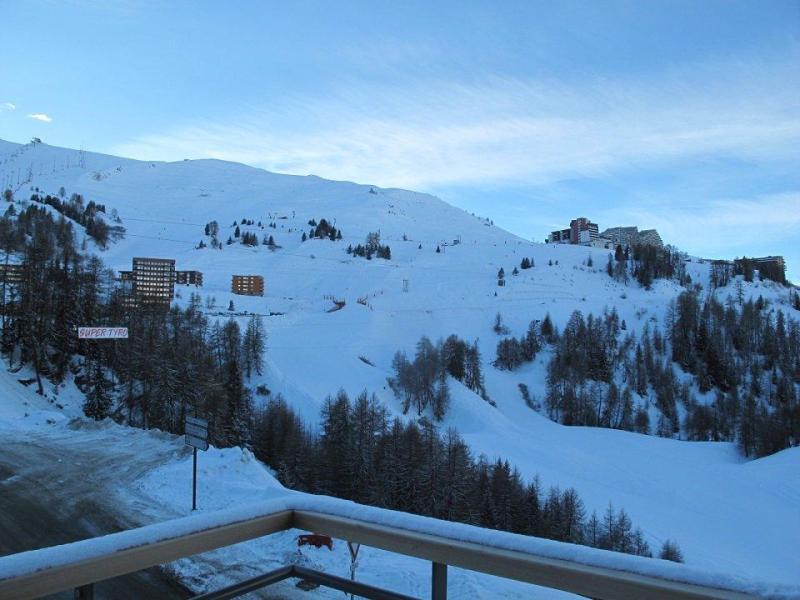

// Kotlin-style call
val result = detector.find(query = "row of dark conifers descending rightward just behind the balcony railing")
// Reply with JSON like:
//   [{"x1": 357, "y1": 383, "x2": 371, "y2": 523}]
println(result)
[{"x1": 253, "y1": 391, "x2": 682, "y2": 560}]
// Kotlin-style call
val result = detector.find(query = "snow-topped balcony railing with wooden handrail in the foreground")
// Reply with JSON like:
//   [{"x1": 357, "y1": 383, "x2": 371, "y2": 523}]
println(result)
[{"x1": 0, "y1": 494, "x2": 780, "y2": 600}]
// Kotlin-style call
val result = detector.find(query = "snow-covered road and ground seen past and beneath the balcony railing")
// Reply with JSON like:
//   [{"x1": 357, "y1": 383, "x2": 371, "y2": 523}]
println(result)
[{"x1": 0, "y1": 421, "x2": 574, "y2": 600}]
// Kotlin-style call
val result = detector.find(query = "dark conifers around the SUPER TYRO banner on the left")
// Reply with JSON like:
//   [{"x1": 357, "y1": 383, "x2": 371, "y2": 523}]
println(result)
[{"x1": 0, "y1": 204, "x2": 266, "y2": 446}]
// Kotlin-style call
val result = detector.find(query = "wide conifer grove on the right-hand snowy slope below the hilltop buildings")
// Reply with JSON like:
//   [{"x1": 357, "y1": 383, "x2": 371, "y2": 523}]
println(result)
[{"x1": 495, "y1": 291, "x2": 800, "y2": 456}]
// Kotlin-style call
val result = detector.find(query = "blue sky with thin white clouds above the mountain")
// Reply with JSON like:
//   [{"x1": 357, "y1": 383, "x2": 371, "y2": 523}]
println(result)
[{"x1": 0, "y1": 0, "x2": 800, "y2": 282}]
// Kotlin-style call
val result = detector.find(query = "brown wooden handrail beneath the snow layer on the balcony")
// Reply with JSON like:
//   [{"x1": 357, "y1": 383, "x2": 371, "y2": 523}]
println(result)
[{"x1": 0, "y1": 509, "x2": 756, "y2": 600}]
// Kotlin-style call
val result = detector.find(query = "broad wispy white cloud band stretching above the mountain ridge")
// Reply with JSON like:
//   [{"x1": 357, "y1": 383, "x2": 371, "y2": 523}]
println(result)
[{"x1": 113, "y1": 56, "x2": 800, "y2": 188}]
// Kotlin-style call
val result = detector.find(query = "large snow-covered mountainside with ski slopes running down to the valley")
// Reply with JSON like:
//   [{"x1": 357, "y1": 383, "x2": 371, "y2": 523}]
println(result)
[{"x1": 0, "y1": 142, "x2": 800, "y2": 584}]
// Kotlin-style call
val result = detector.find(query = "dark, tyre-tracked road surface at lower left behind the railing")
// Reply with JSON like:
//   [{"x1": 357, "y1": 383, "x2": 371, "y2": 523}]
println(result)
[{"x1": 0, "y1": 424, "x2": 191, "y2": 600}]
